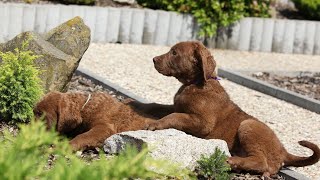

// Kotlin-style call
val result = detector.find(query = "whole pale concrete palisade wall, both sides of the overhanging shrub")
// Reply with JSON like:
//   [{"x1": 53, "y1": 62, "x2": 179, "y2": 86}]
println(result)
[{"x1": 0, "y1": 3, "x2": 320, "y2": 55}]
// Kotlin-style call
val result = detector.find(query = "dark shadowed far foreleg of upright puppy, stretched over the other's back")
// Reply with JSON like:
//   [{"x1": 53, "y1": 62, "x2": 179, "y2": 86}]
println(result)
[{"x1": 125, "y1": 101, "x2": 174, "y2": 119}]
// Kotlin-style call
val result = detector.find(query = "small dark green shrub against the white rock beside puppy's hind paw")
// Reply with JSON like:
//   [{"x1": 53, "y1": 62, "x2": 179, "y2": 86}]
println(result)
[{"x1": 197, "y1": 148, "x2": 232, "y2": 180}]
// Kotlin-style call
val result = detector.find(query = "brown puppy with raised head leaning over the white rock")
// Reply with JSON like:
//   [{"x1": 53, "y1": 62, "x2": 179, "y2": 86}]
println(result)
[{"x1": 131, "y1": 42, "x2": 320, "y2": 177}]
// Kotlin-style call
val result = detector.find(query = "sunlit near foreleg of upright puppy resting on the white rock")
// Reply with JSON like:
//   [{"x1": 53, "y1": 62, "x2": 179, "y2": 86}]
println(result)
[{"x1": 145, "y1": 113, "x2": 203, "y2": 134}]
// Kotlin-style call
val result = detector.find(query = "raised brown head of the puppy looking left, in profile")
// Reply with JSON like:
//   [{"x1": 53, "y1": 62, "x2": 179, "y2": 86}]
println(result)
[{"x1": 153, "y1": 41, "x2": 216, "y2": 84}]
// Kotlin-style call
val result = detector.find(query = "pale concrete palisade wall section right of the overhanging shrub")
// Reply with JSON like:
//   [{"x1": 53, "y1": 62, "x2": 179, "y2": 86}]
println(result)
[{"x1": 209, "y1": 18, "x2": 320, "y2": 55}]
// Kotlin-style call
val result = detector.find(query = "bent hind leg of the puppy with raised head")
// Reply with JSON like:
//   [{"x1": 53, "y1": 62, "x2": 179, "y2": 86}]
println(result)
[{"x1": 228, "y1": 119, "x2": 282, "y2": 178}]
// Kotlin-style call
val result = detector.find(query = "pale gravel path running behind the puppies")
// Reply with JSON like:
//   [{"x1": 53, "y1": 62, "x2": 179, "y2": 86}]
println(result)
[{"x1": 80, "y1": 44, "x2": 320, "y2": 179}]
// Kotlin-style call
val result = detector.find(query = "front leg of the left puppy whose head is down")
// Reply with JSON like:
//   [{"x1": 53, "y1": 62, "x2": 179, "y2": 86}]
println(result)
[{"x1": 70, "y1": 125, "x2": 115, "y2": 150}]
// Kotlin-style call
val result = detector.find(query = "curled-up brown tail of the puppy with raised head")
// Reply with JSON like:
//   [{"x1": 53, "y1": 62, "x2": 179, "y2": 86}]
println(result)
[{"x1": 284, "y1": 141, "x2": 320, "y2": 167}]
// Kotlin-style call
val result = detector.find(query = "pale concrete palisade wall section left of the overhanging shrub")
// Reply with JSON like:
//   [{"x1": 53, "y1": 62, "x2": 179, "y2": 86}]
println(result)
[{"x1": 0, "y1": 3, "x2": 198, "y2": 45}]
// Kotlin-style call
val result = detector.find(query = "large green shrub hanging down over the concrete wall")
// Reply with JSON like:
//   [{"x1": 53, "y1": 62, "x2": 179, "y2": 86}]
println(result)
[{"x1": 137, "y1": 0, "x2": 245, "y2": 37}]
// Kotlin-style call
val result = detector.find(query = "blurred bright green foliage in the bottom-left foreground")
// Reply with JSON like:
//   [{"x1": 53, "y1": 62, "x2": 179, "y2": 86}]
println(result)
[{"x1": 0, "y1": 121, "x2": 192, "y2": 180}]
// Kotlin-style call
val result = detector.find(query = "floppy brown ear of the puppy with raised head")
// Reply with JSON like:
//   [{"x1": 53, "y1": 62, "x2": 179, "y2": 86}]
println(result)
[{"x1": 195, "y1": 41, "x2": 216, "y2": 81}]
